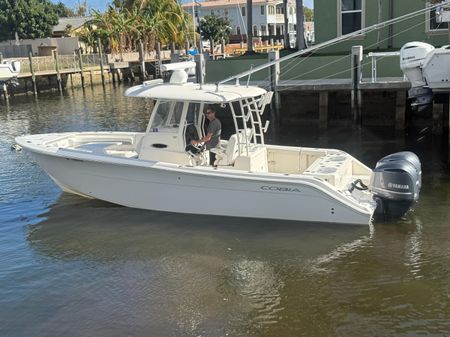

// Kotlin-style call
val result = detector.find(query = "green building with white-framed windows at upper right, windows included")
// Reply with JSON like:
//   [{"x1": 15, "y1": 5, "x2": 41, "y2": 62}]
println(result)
[{"x1": 314, "y1": 0, "x2": 449, "y2": 53}]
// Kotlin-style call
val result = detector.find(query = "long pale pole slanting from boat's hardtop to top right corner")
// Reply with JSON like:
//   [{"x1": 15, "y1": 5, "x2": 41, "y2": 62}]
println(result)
[{"x1": 216, "y1": 0, "x2": 450, "y2": 89}]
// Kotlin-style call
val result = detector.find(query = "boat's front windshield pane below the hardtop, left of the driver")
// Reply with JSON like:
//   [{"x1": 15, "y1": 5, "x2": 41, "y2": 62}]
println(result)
[{"x1": 150, "y1": 101, "x2": 184, "y2": 133}]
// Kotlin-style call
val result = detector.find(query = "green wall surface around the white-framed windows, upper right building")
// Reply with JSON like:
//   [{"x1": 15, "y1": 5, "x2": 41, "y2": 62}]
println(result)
[{"x1": 314, "y1": 0, "x2": 449, "y2": 53}]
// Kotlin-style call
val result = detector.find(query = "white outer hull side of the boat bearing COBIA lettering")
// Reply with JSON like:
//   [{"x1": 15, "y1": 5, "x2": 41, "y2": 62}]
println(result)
[{"x1": 26, "y1": 151, "x2": 373, "y2": 225}]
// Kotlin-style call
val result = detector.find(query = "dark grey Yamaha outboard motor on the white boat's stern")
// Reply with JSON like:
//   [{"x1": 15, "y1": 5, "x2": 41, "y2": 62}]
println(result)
[{"x1": 369, "y1": 152, "x2": 422, "y2": 219}]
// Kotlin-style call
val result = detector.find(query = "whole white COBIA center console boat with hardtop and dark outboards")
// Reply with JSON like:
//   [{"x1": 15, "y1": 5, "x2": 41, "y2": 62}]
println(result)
[{"x1": 16, "y1": 63, "x2": 421, "y2": 225}]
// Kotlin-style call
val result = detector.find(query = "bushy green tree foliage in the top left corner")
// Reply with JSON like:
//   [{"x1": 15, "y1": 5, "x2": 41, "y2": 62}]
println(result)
[{"x1": 0, "y1": 0, "x2": 58, "y2": 41}]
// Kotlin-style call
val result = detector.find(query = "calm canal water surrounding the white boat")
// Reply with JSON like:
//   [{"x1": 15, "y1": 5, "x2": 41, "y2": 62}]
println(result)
[{"x1": 0, "y1": 87, "x2": 450, "y2": 337}]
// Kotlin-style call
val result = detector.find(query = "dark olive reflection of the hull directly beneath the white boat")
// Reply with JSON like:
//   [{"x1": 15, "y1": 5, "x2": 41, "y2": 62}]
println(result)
[{"x1": 28, "y1": 194, "x2": 367, "y2": 259}]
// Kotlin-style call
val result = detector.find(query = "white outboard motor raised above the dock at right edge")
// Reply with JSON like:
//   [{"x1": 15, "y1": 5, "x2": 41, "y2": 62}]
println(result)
[{"x1": 400, "y1": 42, "x2": 450, "y2": 110}]
